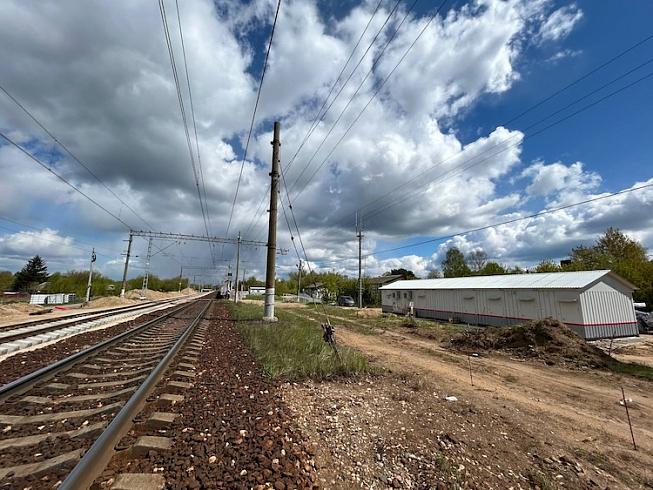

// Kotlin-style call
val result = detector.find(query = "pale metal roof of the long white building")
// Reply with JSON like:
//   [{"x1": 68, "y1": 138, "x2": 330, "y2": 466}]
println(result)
[{"x1": 380, "y1": 270, "x2": 637, "y2": 290}]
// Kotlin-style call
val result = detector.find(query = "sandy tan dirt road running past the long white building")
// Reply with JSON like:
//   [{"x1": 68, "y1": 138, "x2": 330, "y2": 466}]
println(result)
[{"x1": 284, "y1": 310, "x2": 653, "y2": 488}]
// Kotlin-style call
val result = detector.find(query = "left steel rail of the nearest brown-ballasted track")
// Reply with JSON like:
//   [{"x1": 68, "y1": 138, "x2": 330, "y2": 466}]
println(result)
[{"x1": 0, "y1": 301, "x2": 195, "y2": 401}]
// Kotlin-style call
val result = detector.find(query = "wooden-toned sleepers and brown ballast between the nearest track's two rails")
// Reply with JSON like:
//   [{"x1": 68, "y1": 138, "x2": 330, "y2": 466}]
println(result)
[{"x1": 0, "y1": 300, "x2": 207, "y2": 490}]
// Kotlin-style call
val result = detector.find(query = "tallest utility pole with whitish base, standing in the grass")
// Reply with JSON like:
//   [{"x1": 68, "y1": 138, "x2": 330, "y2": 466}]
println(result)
[{"x1": 263, "y1": 121, "x2": 281, "y2": 322}]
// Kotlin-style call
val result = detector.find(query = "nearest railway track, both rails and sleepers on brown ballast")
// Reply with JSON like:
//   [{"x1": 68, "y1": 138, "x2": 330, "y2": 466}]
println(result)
[{"x1": 0, "y1": 299, "x2": 212, "y2": 490}]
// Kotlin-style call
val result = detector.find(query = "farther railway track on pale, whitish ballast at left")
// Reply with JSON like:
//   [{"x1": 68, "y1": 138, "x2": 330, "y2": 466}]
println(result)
[{"x1": 0, "y1": 299, "x2": 194, "y2": 356}]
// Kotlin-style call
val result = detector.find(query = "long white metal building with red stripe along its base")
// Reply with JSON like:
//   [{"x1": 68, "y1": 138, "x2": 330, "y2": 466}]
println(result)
[{"x1": 381, "y1": 270, "x2": 638, "y2": 340}]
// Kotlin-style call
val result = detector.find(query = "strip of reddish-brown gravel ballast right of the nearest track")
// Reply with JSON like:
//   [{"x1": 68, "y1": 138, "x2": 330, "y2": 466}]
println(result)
[{"x1": 96, "y1": 303, "x2": 317, "y2": 490}]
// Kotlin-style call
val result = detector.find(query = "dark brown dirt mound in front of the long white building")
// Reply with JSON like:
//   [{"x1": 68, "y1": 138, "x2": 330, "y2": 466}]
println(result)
[{"x1": 449, "y1": 318, "x2": 613, "y2": 368}]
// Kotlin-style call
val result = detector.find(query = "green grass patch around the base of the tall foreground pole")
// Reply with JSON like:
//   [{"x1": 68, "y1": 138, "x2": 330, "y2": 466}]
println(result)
[{"x1": 230, "y1": 303, "x2": 370, "y2": 381}]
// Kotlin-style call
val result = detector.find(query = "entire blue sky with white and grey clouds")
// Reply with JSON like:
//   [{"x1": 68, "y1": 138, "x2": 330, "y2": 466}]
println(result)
[{"x1": 0, "y1": 0, "x2": 653, "y2": 277}]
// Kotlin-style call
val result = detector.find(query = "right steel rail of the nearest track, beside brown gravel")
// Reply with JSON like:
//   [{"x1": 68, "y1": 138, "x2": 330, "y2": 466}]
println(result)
[{"x1": 58, "y1": 299, "x2": 213, "y2": 490}]
